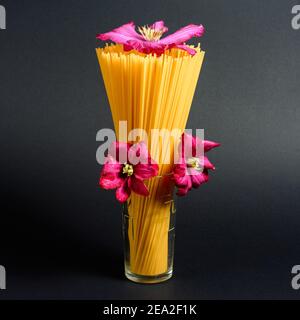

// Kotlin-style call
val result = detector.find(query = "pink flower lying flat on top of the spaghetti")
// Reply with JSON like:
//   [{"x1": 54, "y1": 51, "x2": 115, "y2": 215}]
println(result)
[{"x1": 97, "y1": 21, "x2": 204, "y2": 55}]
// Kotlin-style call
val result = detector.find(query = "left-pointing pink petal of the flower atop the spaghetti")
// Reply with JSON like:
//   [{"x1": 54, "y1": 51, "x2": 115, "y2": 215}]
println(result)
[{"x1": 96, "y1": 22, "x2": 143, "y2": 44}]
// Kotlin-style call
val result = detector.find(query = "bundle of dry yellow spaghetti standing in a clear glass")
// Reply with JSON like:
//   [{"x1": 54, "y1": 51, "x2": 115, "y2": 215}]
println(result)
[{"x1": 96, "y1": 45, "x2": 204, "y2": 276}]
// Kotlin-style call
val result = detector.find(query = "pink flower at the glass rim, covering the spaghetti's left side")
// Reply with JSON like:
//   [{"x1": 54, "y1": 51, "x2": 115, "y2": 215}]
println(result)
[{"x1": 99, "y1": 142, "x2": 158, "y2": 202}]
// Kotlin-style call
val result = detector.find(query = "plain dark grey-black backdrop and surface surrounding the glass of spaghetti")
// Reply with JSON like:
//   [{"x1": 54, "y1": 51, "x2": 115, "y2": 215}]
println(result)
[{"x1": 0, "y1": 0, "x2": 300, "y2": 299}]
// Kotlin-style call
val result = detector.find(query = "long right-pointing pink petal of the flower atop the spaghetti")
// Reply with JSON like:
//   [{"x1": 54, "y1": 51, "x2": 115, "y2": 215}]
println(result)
[{"x1": 160, "y1": 24, "x2": 204, "y2": 45}]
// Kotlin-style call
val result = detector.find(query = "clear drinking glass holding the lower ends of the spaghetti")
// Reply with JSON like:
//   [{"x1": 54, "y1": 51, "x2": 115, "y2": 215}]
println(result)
[{"x1": 122, "y1": 176, "x2": 176, "y2": 283}]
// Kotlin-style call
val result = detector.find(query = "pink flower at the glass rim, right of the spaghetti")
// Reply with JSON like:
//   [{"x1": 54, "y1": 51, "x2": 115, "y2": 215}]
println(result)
[{"x1": 173, "y1": 133, "x2": 220, "y2": 196}]
